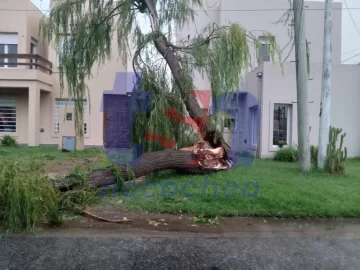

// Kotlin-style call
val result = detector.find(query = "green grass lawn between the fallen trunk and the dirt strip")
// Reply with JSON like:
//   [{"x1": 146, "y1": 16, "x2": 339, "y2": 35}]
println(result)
[{"x1": 101, "y1": 159, "x2": 360, "y2": 217}]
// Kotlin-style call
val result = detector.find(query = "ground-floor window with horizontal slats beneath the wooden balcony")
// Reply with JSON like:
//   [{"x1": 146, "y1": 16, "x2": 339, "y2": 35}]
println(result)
[{"x1": 0, "y1": 98, "x2": 16, "y2": 132}]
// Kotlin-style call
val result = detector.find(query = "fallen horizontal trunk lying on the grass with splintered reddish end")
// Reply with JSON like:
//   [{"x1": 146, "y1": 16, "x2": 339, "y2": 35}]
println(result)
[{"x1": 57, "y1": 141, "x2": 232, "y2": 192}]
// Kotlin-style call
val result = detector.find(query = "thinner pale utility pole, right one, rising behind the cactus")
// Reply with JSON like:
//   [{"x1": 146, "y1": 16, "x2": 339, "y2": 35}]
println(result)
[{"x1": 317, "y1": 0, "x2": 333, "y2": 169}]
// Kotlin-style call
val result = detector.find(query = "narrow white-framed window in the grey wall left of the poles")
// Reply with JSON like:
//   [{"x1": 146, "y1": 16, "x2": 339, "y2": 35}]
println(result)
[{"x1": 273, "y1": 104, "x2": 290, "y2": 146}]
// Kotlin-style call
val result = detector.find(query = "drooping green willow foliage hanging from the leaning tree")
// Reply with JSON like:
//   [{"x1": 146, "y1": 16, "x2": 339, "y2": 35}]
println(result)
[{"x1": 40, "y1": 0, "x2": 278, "y2": 146}]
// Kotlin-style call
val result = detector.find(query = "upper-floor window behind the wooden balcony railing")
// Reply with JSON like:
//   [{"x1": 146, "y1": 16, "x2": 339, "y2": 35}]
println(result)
[{"x1": 0, "y1": 33, "x2": 18, "y2": 68}]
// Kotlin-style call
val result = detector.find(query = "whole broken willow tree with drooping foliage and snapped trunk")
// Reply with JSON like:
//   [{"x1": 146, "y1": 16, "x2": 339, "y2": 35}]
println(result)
[{"x1": 41, "y1": 0, "x2": 276, "y2": 190}]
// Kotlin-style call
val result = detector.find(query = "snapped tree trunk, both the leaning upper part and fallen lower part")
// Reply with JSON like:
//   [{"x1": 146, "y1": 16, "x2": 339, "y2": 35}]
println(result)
[{"x1": 60, "y1": 0, "x2": 232, "y2": 190}]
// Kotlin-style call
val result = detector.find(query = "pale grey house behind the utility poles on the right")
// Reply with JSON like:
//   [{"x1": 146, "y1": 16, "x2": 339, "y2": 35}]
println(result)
[{"x1": 178, "y1": 0, "x2": 360, "y2": 158}]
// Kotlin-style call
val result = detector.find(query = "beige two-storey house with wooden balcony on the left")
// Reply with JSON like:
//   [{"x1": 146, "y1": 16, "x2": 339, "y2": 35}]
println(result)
[{"x1": 0, "y1": 0, "x2": 128, "y2": 147}]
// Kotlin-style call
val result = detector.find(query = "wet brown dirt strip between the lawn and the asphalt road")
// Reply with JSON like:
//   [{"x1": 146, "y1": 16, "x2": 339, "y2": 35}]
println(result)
[{"x1": 28, "y1": 211, "x2": 360, "y2": 237}]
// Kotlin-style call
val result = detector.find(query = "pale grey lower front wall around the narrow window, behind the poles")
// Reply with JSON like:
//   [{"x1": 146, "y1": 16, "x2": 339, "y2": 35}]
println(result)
[{"x1": 261, "y1": 63, "x2": 360, "y2": 157}]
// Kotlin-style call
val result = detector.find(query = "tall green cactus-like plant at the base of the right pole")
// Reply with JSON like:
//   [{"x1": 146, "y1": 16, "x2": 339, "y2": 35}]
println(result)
[{"x1": 325, "y1": 127, "x2": 347, "y2": 174}]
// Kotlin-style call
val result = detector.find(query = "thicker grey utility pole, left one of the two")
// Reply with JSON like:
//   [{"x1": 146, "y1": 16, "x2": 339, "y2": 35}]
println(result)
[{"x1": 293, "y1": 0, "x2": 311, "y2": 172}]
